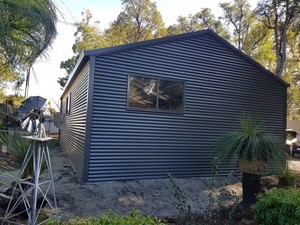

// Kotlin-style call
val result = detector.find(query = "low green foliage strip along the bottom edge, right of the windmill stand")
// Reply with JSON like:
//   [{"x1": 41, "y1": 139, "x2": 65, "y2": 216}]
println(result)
[{"x1": 46, "y1": 210, "x2": 165, "y2": 225}]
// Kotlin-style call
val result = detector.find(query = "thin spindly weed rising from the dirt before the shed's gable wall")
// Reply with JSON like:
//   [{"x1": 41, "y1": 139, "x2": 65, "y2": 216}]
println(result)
[{"x1": 167, "y1": 173, "x2": 195, "y2": 225}]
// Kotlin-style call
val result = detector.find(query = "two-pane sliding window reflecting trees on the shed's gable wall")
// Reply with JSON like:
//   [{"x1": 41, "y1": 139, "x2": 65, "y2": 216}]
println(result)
[{"x1": 128, "y1": 76, "x2": 184, "y2": 112}]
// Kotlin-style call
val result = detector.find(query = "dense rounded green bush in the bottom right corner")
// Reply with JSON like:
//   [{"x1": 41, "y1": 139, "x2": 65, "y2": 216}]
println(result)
[{"x1": 252, "y1": 188, "x2": 300, "y2": 225}]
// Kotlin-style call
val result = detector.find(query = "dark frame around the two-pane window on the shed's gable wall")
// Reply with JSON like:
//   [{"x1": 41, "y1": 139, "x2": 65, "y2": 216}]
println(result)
[{"x1": 127, "y1": 74, "x2": 186, "y2": 114}]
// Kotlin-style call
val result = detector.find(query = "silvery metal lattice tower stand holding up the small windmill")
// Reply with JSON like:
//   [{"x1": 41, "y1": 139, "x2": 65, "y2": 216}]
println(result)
[{"x1": 2, "y1": 136, "x2": 58, "y2": 225}]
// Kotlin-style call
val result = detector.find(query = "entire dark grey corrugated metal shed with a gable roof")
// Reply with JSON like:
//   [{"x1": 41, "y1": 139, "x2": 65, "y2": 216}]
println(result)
[{"x1": 60, "y1": 30, "x2": 288, "y2": 182}]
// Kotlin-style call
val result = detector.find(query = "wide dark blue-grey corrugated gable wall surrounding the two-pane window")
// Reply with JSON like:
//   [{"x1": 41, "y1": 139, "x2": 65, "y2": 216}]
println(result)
[{"x1": 86, "y1": 35, "x2": 286, "y2": 182}]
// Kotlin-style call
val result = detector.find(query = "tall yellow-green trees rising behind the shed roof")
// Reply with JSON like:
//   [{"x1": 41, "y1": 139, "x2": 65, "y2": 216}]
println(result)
[{"x1": 59, "y1": 0, "x2": 300, "y2": 118}]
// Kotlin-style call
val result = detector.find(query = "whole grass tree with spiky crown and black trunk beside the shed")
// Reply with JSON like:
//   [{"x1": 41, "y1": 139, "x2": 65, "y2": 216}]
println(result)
[{"x1": 215, "y1": 114, "x2": 280, "y2": 207}]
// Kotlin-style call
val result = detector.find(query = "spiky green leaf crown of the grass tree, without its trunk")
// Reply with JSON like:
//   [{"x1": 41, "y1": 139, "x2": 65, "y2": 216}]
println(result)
[{"x1": 215, "y1": 114, "x2": 279, "y2": 162}]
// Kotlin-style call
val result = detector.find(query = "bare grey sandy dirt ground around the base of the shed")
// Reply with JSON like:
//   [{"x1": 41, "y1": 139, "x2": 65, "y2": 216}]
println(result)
[{"x1": 0, "y1": 142, "x2": 242, "y2": 219}]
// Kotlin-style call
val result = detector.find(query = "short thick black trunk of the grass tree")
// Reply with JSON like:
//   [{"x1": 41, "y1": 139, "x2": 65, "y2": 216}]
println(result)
[{"x1": 242, "y1": 173, "x2": 261, "y2": 207}]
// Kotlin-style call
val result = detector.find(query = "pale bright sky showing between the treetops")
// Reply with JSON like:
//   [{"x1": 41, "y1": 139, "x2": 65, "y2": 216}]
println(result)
[{"x1": 13, "y1": 0, "x2": 258, "y2": 108}]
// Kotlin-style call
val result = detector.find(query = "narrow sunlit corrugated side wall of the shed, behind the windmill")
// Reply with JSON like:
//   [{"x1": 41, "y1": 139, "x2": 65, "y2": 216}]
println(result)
[{"x1": 60, "y1": 63, "x2": 89, "y2": 177}]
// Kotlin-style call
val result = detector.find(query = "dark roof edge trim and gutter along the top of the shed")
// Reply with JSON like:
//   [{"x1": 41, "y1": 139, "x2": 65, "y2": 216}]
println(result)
[{"x1": 63, "y1": 29, "x2": 289, "y2": 95}]
